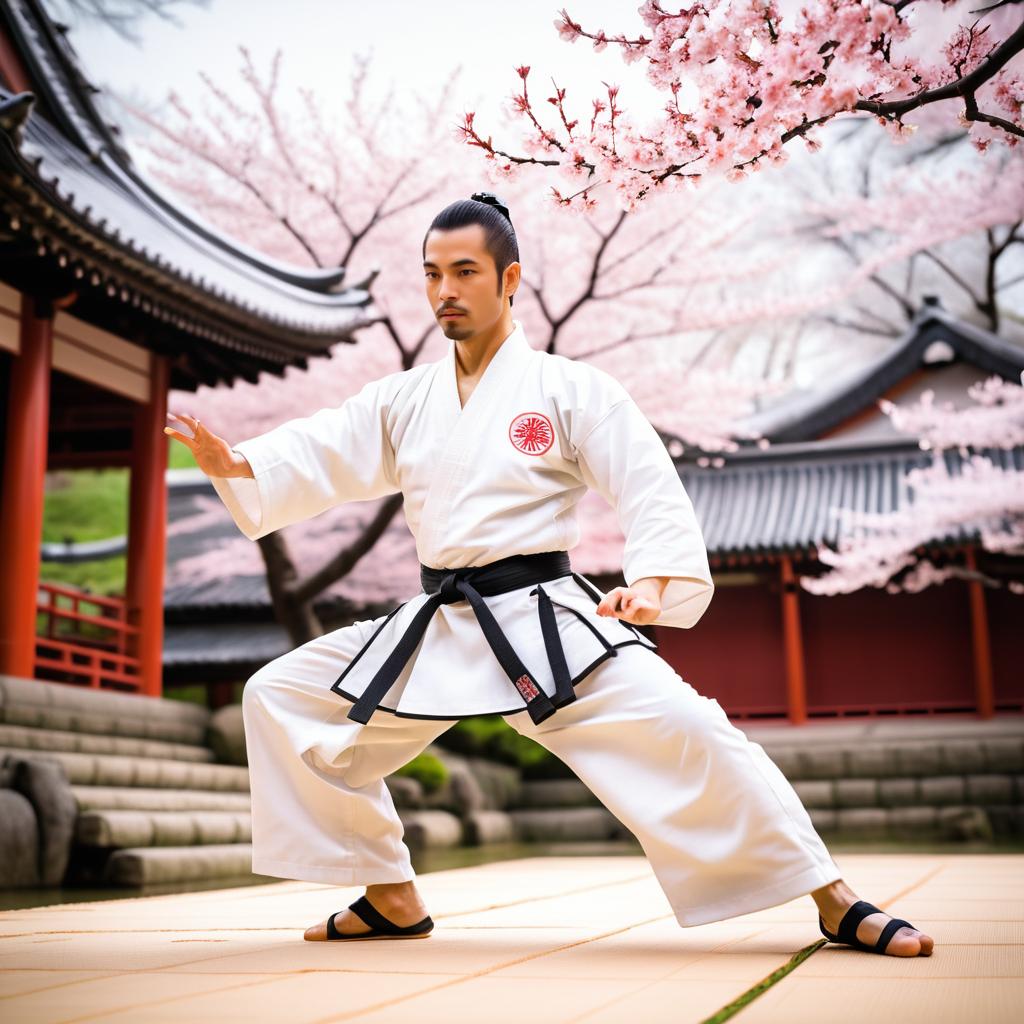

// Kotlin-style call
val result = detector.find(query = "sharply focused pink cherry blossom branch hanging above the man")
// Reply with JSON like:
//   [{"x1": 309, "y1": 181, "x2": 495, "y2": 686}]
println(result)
[{"x1": 459, "y1": 0, "x2": 1024, "y2": 211}]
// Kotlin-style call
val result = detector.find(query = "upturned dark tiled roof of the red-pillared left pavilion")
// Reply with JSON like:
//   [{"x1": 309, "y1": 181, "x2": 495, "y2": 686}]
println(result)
[{"x1": 0, "y1": 0, "x2": 377, "y2": 389}]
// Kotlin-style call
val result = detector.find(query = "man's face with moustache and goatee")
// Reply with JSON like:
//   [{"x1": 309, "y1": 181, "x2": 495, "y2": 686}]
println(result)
[{"x1": 423, "y1": 224, "x2": 509, "y2": 341}]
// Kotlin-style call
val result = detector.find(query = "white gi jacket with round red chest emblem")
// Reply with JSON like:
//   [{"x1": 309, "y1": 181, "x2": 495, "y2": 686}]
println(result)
[{"x1": 212, "y1": 321, "x2": 714, "y2": 719}]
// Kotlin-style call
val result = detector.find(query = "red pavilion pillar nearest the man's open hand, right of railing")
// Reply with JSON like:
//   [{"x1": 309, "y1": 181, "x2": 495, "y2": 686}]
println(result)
[{"x1": 125, "y1": 353, "x2": 169, "y2": 696}]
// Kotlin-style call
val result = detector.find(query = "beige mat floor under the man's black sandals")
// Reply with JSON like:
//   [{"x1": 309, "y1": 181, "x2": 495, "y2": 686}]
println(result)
[{"x1": 0, "y1": 854, "x2": 1024, "y2": 1024}]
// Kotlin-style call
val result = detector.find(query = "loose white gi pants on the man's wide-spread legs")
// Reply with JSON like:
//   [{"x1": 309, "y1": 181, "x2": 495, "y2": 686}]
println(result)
[{"x1": 243, "y1": 627, "x2": 842, "y2": 927}]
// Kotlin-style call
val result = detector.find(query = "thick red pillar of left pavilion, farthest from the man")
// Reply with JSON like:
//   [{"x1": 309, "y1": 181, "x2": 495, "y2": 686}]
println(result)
[{"x1": 0, "y1": 295, "x2": 53, "y2": 679}]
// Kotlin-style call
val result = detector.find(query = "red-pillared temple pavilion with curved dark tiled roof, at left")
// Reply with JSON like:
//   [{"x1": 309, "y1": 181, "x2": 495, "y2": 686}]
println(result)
[{"x1": 0, "y1": 0, "x2": 374, "y2": 694}]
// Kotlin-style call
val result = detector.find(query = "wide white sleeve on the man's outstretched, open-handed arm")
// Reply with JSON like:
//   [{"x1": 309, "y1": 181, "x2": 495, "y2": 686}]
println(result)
[{"x1": 210, "y1": 378, "x2": 400, "y2": 541}]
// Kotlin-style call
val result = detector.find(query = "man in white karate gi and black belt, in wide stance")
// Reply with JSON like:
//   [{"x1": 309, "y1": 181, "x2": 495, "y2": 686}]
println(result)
[{"x1": 168, "y1": 193, "x2": 932, "y2": 956}]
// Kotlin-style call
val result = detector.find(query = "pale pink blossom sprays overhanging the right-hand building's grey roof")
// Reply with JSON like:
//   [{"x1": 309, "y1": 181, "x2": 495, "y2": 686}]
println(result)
[{"x1": 800, "y1": 377, "x2": 1024, "y2": 594}]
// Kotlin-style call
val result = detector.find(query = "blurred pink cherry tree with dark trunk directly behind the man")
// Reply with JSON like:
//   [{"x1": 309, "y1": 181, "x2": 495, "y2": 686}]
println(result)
[{"x1": 119, "y1": 49, "x2": 769, "y2": 643}]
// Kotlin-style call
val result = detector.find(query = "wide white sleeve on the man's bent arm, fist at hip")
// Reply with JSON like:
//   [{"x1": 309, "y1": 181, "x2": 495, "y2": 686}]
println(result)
[{"x1": 575, "y1": 397, "x2": 715, "y2": 628}]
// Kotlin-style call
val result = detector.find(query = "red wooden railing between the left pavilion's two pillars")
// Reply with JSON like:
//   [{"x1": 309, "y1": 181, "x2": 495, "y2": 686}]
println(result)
[{"x1": 33, "y1": 582, "x2": 141, "y2": 691}]
